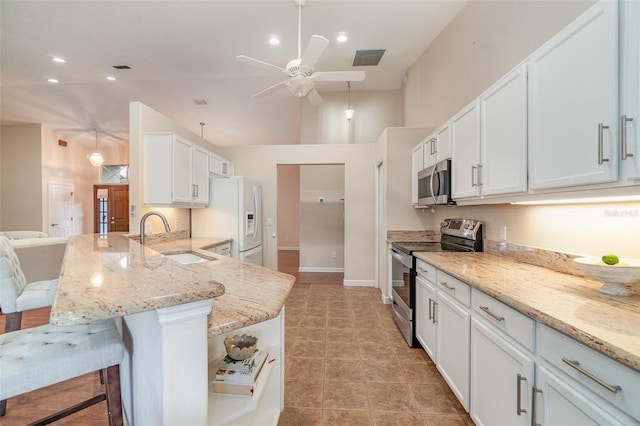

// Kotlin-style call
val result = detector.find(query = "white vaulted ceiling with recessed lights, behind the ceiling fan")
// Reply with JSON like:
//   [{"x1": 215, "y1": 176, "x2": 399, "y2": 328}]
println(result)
[{"x1": 0, "y1": 0, "x2": 465, "y2": 145}]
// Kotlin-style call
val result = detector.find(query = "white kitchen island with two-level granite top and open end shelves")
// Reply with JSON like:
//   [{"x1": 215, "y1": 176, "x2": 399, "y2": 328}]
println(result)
[{"x1": 50, "y1": 233, "x2": 295, "y2": 425}]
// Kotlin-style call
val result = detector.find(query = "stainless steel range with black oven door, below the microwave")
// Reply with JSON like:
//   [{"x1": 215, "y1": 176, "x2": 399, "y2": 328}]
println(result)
[{"x1": 391, "y1": 219, "x2": 483, "y2": 347}]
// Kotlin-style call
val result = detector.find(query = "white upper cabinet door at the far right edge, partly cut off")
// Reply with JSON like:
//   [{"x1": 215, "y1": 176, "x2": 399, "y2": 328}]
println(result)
[{"x1": 620, "y1": 1, "x2": 640, "y2": 180}]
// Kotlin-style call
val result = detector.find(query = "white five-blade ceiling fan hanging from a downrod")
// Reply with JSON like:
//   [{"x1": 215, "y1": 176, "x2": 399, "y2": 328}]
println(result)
[{"x1": 236, "y1": 0, "x2": 366, "y2": 105}]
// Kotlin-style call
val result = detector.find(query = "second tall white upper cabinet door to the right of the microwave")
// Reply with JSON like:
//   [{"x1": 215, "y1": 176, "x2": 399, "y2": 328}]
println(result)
[{"x1": 480, "y1": 64, "x2": 527, "y2": 195}]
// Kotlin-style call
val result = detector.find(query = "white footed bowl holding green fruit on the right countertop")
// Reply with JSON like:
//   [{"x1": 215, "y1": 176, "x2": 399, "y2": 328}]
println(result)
[{"x1": 573, "y1": 257, "x2": 640, "y2": 296}]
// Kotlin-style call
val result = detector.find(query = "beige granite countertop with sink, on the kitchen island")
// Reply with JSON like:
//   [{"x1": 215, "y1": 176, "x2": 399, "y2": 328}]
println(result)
[{"x1": 50, "y1": 233, "x2": 295, "y2": 336}]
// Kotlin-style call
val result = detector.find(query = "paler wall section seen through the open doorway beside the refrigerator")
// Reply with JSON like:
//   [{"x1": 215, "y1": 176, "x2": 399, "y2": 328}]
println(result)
[{"x1": 300, "y1": 164, "x2": 344, "y2": 272}]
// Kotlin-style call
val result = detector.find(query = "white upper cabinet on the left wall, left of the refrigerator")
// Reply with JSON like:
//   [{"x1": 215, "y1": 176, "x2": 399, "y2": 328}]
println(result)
[{"x1": 143, "y1": 133, "x2": 209, "y2": 207}]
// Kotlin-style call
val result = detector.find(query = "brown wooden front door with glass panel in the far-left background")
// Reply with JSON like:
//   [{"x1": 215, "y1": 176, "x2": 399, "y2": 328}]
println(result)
[{"x1": 93, "y1": 185, "x2": 129, "y2": 234}]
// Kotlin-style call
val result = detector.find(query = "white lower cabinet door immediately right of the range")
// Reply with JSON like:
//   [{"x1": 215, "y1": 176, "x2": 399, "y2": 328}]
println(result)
[{"x1": 416, "y1": 275, "x2": 436, "y2": 362}]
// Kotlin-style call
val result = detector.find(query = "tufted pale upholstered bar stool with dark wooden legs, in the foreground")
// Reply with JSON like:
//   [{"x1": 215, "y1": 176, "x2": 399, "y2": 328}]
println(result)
[{"x1": 0, "y1": 319, "x2": 124, "y2": 425}]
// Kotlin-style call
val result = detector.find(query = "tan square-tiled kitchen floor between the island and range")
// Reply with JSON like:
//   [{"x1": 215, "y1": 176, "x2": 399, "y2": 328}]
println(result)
[{"x1": 279, "y1": 251, "x2": 473, "y2": 425}]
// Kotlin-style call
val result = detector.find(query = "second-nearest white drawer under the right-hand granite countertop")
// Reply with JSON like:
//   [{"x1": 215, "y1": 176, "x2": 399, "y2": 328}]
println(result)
[{"x1": 471, "y1": 288, "x2": 536, "y2": 352}]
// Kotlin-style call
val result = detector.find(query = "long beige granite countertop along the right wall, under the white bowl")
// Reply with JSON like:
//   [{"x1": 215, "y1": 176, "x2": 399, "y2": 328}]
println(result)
[{"x1": 414, "y1": 252, "x2": 640, "y2": 371}]
